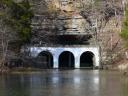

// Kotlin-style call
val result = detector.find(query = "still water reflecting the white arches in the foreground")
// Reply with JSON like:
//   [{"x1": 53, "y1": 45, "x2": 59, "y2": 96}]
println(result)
[{"x1": 0, "y1": 69, "x2": 128, "y2": 96}]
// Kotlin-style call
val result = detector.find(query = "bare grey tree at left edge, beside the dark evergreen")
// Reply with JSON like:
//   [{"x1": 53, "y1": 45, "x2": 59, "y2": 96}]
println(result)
[{"x1": 0, "y1": 8, "x2": 19, "y2": 69}]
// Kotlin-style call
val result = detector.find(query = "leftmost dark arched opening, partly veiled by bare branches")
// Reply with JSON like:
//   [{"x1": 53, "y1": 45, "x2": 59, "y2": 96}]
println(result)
[{"x1": 35, "y1": 51, "x2": 53, "y2": 69}]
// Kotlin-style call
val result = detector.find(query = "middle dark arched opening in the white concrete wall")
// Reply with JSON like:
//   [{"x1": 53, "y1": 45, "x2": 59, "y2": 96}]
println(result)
[{"x1": 59, "y1": 51, "x2": 75, "y2": 68}]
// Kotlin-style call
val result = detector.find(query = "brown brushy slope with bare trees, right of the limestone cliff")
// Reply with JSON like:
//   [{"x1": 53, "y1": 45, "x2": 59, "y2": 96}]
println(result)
[{"x1": 80, "y1": 0, "x2": 125, "y2": 64}]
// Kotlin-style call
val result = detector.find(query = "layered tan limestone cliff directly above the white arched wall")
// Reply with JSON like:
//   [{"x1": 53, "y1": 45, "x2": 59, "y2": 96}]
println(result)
[{"x1": 30, "y1": 0, "x2": 97, "y2": 43}]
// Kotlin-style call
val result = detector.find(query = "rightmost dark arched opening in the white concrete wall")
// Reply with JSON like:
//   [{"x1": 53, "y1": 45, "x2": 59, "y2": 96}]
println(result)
[{"x1": 80, "y1": 51, "x2": 94, "y2": 68}]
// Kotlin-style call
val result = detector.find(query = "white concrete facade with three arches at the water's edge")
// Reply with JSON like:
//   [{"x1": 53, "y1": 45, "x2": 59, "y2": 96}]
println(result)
[{"x1": 29, "y1": 46, "x2": 100, "y2": 68}]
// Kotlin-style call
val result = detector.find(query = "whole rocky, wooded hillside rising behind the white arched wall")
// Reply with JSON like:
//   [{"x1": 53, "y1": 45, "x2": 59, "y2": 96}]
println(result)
[{"x1": 0, "y1": 0, "x2": 126, "y2": 70}]
